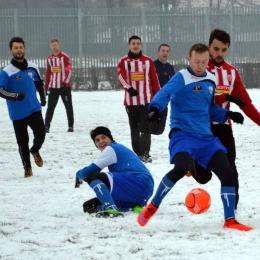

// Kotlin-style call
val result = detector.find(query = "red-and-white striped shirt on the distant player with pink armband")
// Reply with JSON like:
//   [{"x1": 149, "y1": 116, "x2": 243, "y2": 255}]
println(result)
[{"x1": 44, "y1": 52, "x2": 71, "y2": 89}]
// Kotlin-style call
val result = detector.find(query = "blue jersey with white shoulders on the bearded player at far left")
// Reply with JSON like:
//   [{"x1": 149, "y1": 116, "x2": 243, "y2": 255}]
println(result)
[{"x1": 0, "y1": 62, "x2": 42, "y2": 120}]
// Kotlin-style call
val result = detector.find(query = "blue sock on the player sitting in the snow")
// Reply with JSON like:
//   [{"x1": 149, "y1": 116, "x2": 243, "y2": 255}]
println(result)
[{"x1": 89, "y1": 180, "x2": 117, "y2": 210}]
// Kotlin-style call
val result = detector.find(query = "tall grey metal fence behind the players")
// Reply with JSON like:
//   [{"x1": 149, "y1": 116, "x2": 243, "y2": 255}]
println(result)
[{"x1": 0, "y1": 6, "x2": 260, "y2": 89}]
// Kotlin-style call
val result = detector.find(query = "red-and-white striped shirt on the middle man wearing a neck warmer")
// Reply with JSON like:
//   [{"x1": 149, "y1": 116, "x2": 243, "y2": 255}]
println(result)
[{"x1": 118, "y1": 54, "x2": 160, "y2": 106}]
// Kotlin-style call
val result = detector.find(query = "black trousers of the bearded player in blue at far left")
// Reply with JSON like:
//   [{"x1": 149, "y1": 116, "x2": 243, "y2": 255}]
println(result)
[{"x1": 13, "y1": 111, "x2": 45, "y2": 168}]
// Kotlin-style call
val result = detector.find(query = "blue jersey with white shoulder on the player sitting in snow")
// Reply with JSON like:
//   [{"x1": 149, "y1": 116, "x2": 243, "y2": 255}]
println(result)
[{"x1": 77, "y1": 142, "x2": 154, "y2": 190}]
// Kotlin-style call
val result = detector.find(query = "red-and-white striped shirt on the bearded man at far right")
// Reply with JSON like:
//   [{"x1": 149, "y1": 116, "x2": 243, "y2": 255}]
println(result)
[{"x1": 207, "y1": 59, "x2": 260, "y2": 126}]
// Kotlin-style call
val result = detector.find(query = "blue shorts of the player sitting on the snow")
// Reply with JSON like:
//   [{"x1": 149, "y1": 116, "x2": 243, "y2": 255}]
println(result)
[{"x1": 105, "y1": 172, "x2": 153, "y2": 210}]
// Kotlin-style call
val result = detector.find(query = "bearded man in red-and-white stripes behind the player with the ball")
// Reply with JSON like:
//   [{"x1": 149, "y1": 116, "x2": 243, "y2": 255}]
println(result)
[{"x1": 190, "y1": 29, "x2": 260, "y2": 209}]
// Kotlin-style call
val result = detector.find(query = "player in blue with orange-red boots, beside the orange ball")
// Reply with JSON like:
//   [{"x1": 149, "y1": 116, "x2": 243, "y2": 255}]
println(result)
[{"x1": 138, "y1": 43, "x2": 252, "y2": 231}]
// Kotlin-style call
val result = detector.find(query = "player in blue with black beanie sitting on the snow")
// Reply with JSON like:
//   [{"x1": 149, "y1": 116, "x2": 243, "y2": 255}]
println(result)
[{"x1": 75, "y1": 126, "x2": 154, "y2": 217}]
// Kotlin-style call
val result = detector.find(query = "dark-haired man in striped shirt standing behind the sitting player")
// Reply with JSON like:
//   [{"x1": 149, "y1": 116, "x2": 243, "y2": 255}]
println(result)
[{"x1": 118, "y1": 36, "x2": 160, "y2": 163}]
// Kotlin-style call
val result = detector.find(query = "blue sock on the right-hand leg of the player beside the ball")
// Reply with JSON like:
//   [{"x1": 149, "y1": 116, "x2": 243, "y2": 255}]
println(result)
[{"x1": 220, "y1": 187, "x2": 236, "y2": 220}]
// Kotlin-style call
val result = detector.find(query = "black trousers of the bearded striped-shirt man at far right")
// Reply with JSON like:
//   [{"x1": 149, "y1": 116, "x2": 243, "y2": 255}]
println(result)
[{"x1": 191, "y1": 124, "x2": 239, "y2": 208}]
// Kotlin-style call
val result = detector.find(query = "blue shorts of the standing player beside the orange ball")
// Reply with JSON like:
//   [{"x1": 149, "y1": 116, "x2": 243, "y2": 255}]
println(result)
[{"x1": 169, "y1": 131, "x2": 227, "y2": 169}]
